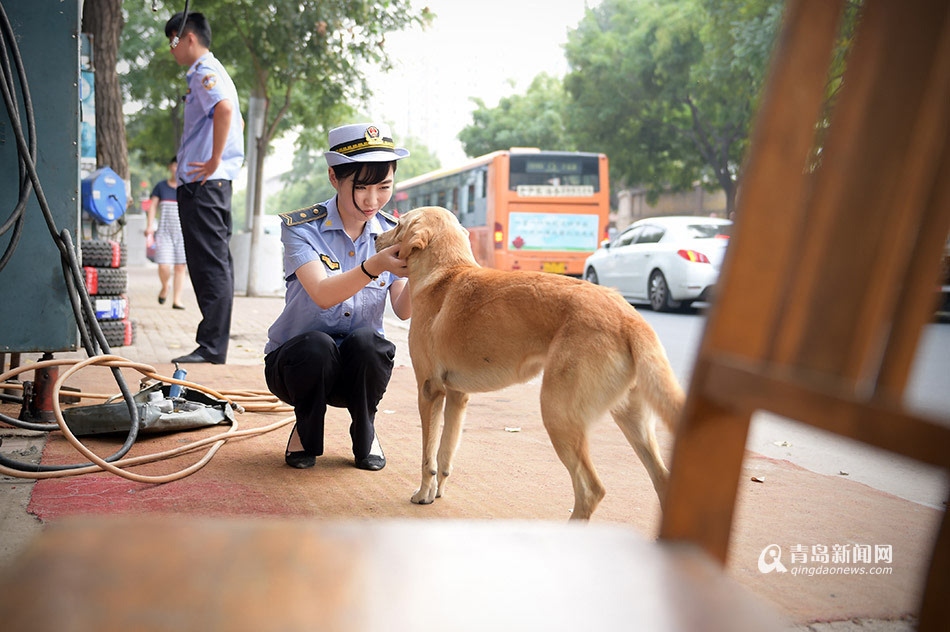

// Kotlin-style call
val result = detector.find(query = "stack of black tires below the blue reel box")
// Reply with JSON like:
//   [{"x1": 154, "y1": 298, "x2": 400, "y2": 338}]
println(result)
[{"x1": 82, "y1": 239, "x2": 135, "y2": 347}]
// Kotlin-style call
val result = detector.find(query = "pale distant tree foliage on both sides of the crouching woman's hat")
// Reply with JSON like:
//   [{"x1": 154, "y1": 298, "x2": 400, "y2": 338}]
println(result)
[{"x1": 266, "y1": 132, "x2": 441, "y2": 214}]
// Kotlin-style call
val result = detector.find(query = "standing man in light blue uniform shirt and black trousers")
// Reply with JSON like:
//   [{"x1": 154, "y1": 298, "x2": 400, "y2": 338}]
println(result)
[{"x1": 165, "y1": 13, "x2": 244, "y2": 364}]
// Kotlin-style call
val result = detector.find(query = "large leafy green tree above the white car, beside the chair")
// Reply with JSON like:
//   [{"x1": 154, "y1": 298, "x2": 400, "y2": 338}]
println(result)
[{"x1": 564, "y1": 0, "x2": 784, "y2": 211}]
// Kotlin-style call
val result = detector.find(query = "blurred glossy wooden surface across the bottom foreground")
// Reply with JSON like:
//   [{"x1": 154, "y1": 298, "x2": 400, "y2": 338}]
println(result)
[{"x1": 0, "y1": 516, "x2": 785, "y2": 632}]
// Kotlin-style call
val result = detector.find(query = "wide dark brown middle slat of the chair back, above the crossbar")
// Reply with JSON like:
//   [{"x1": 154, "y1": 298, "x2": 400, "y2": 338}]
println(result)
[{"x1": 777, "y1": 0, "x2": 946, "y2": 383}]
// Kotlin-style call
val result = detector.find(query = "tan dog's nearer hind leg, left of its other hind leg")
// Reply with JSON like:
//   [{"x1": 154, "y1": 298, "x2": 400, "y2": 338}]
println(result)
[{"x1": 541, "y1": 388, "x2": 605, "y2": 520}]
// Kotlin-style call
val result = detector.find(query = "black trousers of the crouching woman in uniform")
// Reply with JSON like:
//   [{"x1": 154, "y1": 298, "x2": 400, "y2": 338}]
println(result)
[{"x1": 264, "y1": 327, "x2": 396, "y2": 460}]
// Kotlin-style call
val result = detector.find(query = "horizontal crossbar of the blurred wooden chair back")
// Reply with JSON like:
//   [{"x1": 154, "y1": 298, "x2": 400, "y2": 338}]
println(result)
[{"x1": 703, "y1": 356, "x2": 950, "y2": 468}]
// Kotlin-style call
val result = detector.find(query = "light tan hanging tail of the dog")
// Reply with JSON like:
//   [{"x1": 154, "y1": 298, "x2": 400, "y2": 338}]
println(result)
[{"x1": 628, "y1": 318, "x2": 686, "y2": 432}]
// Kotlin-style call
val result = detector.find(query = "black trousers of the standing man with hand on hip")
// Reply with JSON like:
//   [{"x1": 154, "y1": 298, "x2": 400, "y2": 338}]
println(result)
[{"x1": 177, "y1": 180, "x2": 234, "y2": 362}]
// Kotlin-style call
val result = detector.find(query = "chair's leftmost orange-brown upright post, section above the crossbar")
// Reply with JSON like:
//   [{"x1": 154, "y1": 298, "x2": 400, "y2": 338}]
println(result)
[{"x1": 702, "y1": 0, "x2": 842, "y2": 357}]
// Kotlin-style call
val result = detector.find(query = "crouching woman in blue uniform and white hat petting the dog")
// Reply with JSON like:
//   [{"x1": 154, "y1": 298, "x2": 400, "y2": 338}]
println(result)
[{"x1": 264, "y1": 124, "x2": 412, "y2": 470}]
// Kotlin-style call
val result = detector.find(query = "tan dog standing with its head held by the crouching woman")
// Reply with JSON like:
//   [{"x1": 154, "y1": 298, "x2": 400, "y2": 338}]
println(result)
[{"x1": 376, "y1": 207, "x2": 683, "y2": 519}]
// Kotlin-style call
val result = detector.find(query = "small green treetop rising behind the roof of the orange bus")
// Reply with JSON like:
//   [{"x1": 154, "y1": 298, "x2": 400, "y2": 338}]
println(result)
[{"x1": 458, "y1": 73, "x2": 576, "y2": 156}]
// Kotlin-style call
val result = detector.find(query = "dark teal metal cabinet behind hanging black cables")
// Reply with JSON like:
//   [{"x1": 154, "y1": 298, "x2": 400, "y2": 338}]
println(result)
[{"x1": 0, "y1": 0, "x2": 81, "y2": 353}]
